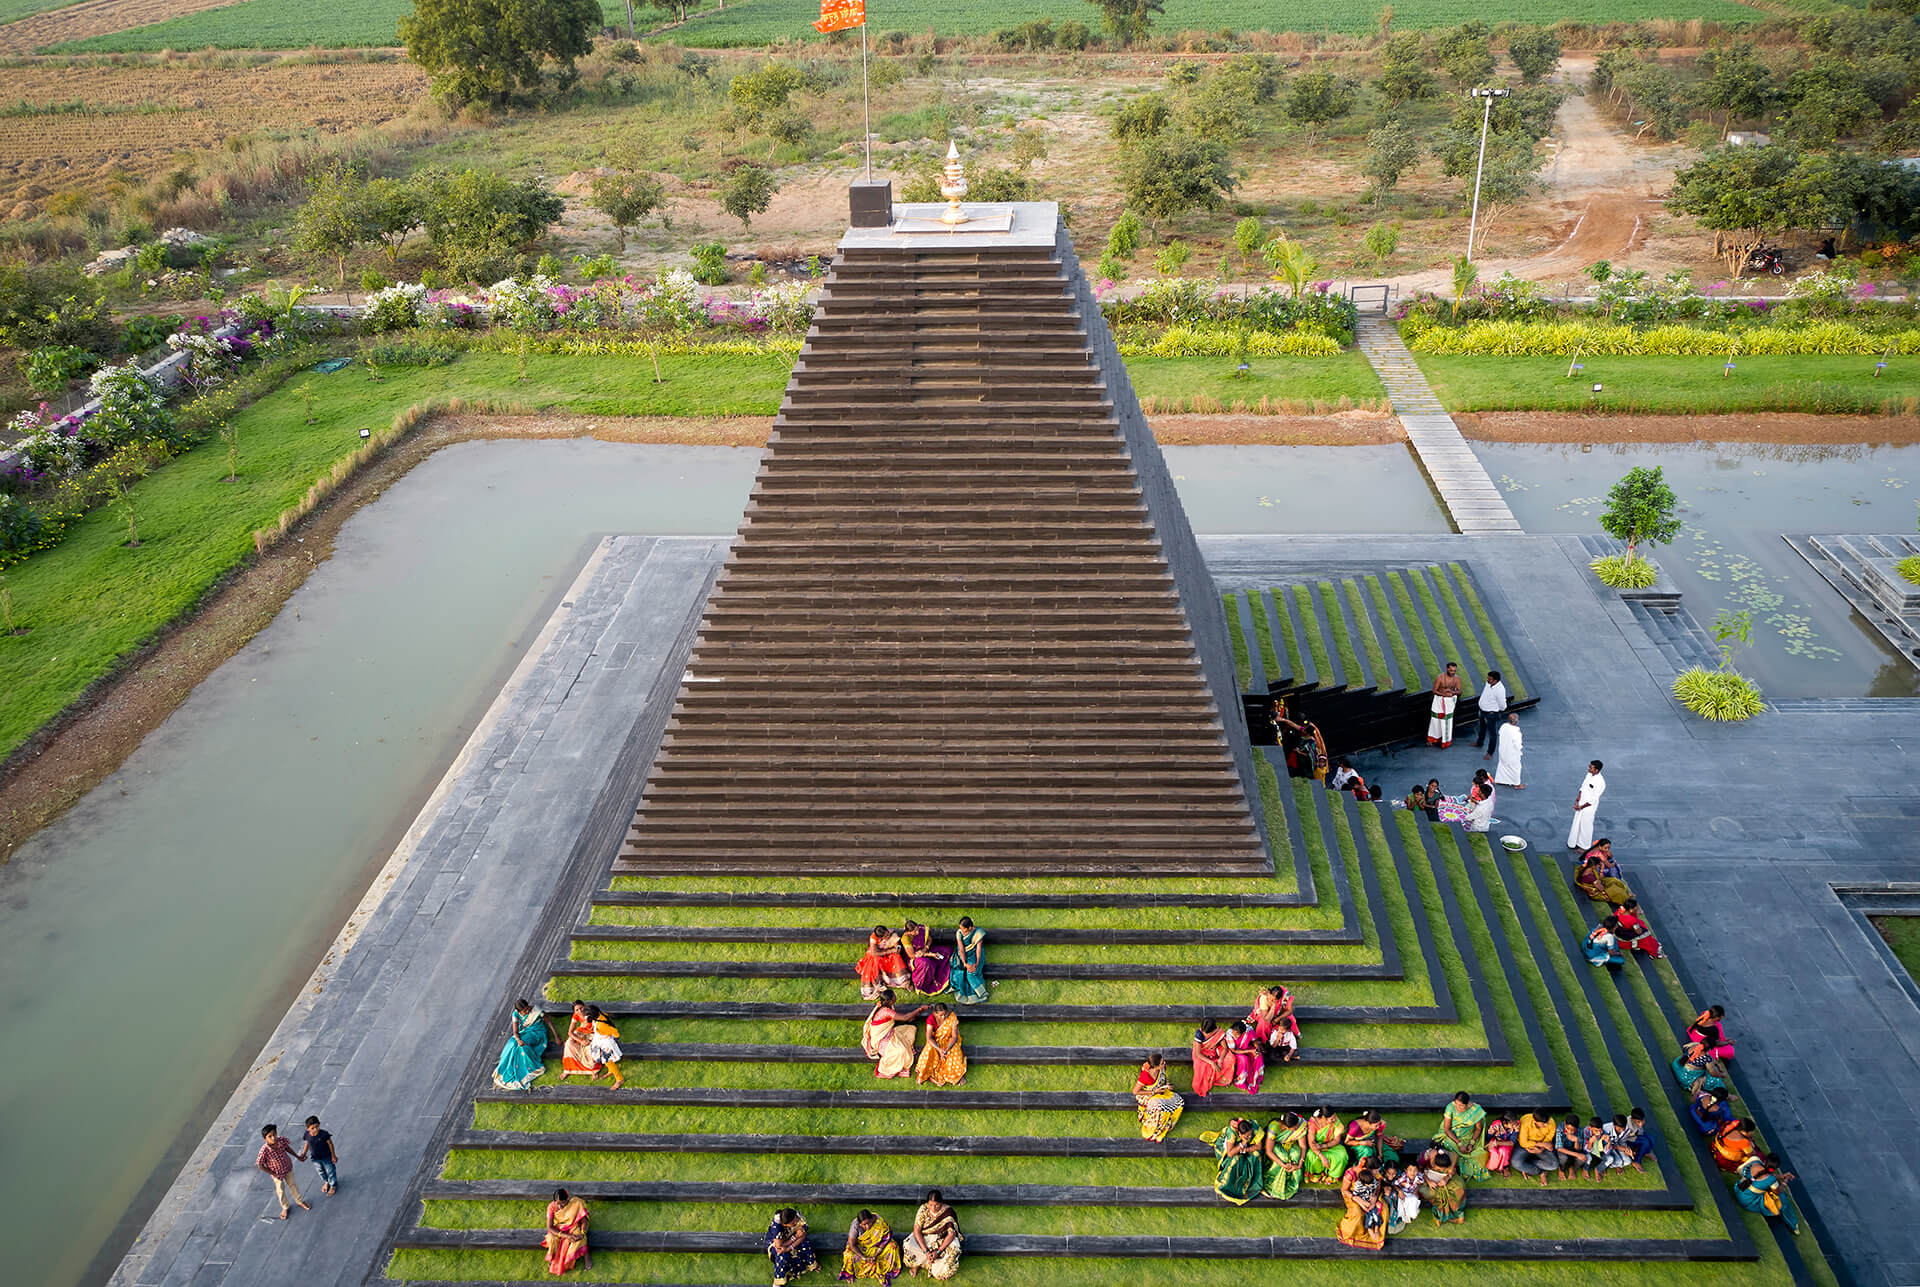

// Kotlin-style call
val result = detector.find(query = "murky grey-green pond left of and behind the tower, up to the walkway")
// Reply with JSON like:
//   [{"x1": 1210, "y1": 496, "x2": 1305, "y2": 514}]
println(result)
[{"x1": 0, "y1": 442, "x2": 1446, "y2": 1287}]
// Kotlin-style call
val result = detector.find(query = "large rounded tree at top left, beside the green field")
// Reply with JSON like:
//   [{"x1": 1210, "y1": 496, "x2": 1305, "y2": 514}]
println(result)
[{"x1": 399, "y1": 0, "x2": 601, "y2": 104}]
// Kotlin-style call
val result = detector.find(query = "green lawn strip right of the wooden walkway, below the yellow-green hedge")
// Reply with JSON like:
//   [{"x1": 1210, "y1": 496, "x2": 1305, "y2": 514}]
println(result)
[{"x1": 1419, "y1": 357, "x2": 1920, "y2": 413}]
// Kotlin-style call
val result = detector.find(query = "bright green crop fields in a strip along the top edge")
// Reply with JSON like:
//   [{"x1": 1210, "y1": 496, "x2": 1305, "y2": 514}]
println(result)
[{"x1": 48, "y1": 0, "x2": 1761, "y2": 52}]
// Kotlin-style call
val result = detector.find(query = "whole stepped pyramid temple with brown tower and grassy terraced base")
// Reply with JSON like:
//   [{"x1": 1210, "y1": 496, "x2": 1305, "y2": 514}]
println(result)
[{"x1": 374, "y1": 194, "x2": 1836, "y2": 1287}]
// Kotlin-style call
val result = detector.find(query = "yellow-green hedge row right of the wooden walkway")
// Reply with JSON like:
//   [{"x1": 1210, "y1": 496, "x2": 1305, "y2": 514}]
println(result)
[{"x1": 1407, "y1": 321, "x2": 1920, "y2": 357}]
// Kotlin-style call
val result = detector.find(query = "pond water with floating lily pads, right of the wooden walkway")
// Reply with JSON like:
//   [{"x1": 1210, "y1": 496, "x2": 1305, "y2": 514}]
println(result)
[{"x1": 1473, "y1": 442, "x2": 1920, "y2": 697}]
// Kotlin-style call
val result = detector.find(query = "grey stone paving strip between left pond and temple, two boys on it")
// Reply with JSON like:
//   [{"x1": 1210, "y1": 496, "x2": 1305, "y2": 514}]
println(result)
[{"x1": 111, "y1": 536, "x2": 726, "y2": 1287}]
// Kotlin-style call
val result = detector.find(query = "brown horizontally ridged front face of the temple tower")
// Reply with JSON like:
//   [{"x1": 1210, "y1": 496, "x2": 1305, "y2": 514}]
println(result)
[{"x1": 614, "y1": 246, "x2": 1273, "y2": 876}]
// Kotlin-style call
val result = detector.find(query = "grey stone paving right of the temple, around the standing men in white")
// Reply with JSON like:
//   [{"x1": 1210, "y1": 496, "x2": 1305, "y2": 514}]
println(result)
[{"x1": 1202, "y1": 534, "x2": 1920, "y2": 1287}]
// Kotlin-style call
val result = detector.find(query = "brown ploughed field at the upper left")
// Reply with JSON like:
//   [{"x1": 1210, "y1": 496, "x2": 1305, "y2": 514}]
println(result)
[{"x1": 0, "y1": 60, "x2": 426, "y2": 219}]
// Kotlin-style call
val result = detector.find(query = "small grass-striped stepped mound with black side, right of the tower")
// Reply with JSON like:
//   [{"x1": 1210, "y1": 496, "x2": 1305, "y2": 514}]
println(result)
[{"x1": 1225, "y1": 563, "x2": 1540, "y2": 768}]
